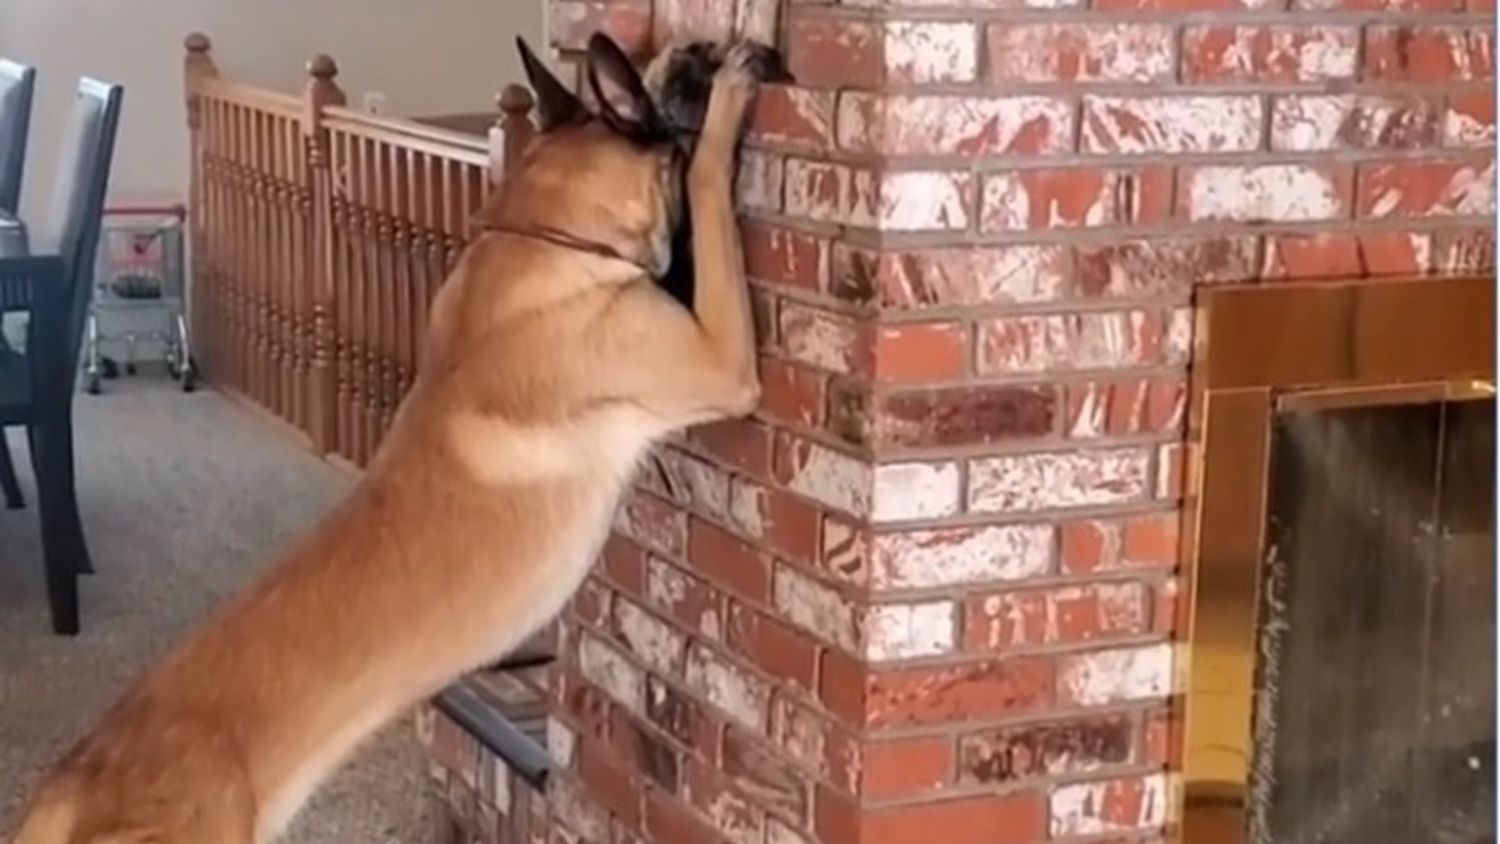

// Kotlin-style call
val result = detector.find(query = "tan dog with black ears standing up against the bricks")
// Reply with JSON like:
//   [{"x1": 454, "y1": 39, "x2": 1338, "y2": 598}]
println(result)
[{"x1": 15, "y1": 36, "x2": 759, "y2": 844}]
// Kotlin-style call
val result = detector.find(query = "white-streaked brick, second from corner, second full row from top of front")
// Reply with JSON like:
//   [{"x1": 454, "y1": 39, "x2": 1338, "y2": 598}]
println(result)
[{"x1": 1082, "y1": 96, "x2": 1263, "y2": 153}]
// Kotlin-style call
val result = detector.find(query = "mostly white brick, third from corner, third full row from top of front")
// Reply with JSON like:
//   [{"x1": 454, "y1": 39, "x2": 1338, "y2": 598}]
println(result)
[{"x1": 1179, "y1": 163, "x2": 1347, "y2": 222}]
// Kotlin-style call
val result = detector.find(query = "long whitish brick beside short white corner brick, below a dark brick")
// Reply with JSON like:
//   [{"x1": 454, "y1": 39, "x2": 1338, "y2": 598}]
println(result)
[{"x1": 969, "y1": 448, "x2": 1151, "y2": 513}]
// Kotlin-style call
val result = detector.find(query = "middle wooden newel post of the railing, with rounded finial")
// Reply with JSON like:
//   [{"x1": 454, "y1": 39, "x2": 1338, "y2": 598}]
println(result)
[{"x1": 302, "y1": 54, "x2": 348, "y2": 454}]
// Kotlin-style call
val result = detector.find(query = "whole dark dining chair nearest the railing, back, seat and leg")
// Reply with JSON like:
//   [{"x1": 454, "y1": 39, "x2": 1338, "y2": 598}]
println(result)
[{"x1": 0, "y1": 79, "x2": 125, "y2": 636}]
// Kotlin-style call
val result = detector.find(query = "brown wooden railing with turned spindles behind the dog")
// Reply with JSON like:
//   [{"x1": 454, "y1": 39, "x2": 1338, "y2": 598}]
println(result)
[{"x1": 183, "y1": 33, "x2": 534, "y2": 466}]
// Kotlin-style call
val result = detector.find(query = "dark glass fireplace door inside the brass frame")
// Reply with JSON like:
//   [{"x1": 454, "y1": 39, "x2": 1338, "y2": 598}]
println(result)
[{"x1": 1245, "y1": 399, "x2": 1496, "y2": 844}]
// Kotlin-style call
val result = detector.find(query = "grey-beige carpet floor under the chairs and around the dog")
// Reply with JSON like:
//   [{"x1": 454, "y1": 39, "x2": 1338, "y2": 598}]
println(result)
[{"x1": 0, "y1": 376, "x2": 429, "y2": 844}]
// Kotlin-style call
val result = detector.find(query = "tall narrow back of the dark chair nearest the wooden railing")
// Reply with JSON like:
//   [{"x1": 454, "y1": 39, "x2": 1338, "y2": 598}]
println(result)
[{"x1": 29, "y1": 76, "x2": 125, "y2": 386}]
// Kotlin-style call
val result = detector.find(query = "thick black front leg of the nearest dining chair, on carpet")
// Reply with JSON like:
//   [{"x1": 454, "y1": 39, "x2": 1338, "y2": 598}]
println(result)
[{"x1": 29, "y1": 414, "x2": 84, "y2": 636}]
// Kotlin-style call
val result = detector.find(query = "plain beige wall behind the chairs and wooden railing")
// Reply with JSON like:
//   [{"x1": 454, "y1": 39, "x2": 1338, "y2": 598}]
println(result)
[{"x1": 0, "y1": 0, "x2": 543, "y2": 230}]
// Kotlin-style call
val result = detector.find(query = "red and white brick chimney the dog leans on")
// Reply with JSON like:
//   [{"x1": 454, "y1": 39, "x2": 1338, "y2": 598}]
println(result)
[{"x1": 425, "y1": 0, "x2": 1496, "y2": 844}]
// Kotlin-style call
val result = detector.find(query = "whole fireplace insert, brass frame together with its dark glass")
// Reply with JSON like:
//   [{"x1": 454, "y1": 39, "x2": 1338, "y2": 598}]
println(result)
[{"x1": 1182, "y1": 277, "x2": 1496, "y2": 844}]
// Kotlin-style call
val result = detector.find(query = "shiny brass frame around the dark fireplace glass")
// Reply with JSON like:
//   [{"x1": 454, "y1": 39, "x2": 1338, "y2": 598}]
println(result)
[{"x1": 1179, "y1": 277, "x2": 1496, "y2": 844}]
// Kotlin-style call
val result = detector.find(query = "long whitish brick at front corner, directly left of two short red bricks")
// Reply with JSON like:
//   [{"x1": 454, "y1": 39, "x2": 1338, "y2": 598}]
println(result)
[{"x1": 870, "y1": 525, "x2": 1056, "y2": 589}]
